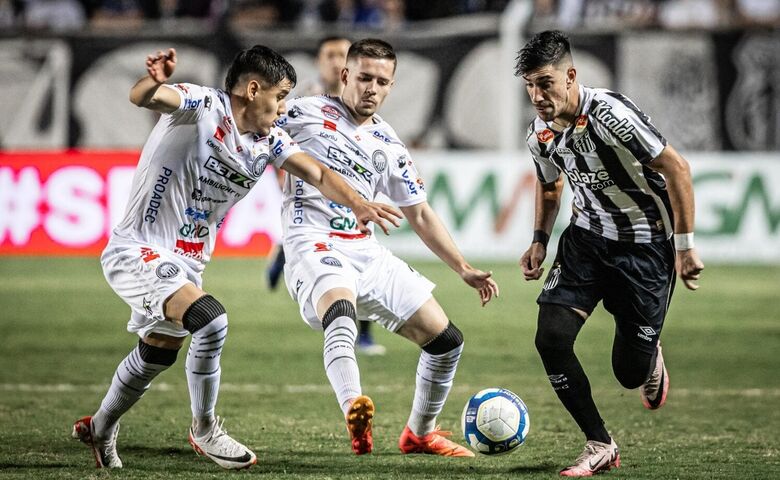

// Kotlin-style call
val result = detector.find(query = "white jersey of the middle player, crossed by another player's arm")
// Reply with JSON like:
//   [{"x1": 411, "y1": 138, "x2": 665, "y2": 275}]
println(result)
[{"x1": 276, "y1": 95, "x2": 427, "y2": 241}]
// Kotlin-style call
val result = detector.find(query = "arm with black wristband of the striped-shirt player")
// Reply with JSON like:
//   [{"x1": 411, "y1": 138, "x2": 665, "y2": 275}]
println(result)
[{"x1": 520, "y1": 176, "x2": 563, "y2": 280}]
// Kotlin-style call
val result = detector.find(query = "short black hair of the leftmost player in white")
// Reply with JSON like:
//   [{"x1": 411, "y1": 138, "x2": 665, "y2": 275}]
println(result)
[{"x1": 225, "y1": 45, "x2": 298, "y2": 92}]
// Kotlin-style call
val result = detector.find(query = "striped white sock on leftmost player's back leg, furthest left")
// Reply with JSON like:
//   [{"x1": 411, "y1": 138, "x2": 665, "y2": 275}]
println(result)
[{"x1": 92, "y1": 346, "x2": 170, "y2": 439}]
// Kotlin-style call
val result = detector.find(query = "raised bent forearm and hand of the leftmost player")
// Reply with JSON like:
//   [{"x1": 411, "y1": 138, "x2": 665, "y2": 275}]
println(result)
[{"x1": 130, "y1": 48, "x2": 181, "y2": 113}]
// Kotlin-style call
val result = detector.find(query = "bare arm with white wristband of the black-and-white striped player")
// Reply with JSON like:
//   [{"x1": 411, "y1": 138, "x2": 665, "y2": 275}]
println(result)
[{"x1": 650, "y1": 145, "x2": 704, "y2": 290}]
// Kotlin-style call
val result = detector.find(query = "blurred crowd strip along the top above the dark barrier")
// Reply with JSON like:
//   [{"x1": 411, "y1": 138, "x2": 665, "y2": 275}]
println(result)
[{"x1": 0, "y1": 0, "x2": 780, "y2": 32}]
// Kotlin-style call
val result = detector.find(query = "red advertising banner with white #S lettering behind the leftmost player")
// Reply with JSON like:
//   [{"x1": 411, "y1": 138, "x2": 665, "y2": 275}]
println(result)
[{"x1": 0, "y1": 150, "x2": 281, "y2": 256}]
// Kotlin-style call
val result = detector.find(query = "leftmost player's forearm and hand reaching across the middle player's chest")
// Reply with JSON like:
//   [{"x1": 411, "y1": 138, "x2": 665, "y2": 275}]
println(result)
[{"x1": 282, "y1": 153, "x2": 401, "y2": 235}]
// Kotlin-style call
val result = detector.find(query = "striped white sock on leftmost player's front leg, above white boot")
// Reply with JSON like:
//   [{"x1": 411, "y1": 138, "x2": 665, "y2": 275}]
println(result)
[{"x1": 185, "y1": 313, "x2": 228, "y2": 437}]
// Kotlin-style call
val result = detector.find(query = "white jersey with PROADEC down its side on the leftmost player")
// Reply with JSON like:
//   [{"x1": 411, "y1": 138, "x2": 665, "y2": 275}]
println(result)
[{"x1": 113, "y1": 83, "x2": 301, "y2": 271}]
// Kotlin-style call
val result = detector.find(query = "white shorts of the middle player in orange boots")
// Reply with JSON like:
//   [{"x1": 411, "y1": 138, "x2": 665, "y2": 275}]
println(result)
[{"x1": 284, "y1": 235, "x2": 436, "y2": 332}]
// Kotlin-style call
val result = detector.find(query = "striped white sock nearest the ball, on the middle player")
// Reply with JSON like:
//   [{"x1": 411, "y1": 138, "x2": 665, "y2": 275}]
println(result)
[{"x1": 407, "y1": 344, "x2": 463, "y2": 437}]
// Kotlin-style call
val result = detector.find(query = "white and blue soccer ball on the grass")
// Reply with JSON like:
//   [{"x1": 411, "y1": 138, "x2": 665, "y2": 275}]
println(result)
[{"x1": 460, "y1": 388, "x2": 530, "y2": 455}]
